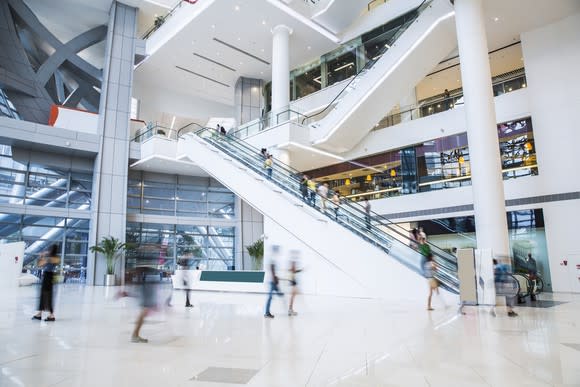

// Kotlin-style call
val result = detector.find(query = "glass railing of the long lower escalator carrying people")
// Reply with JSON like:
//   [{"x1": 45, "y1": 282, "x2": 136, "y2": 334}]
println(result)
[{"x1": 178, "y1": 124, "x2": 459, "y2": 293}]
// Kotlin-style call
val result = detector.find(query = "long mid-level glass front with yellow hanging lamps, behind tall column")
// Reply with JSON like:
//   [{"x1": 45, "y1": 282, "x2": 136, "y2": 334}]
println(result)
[{"x1": 305, "y1": 118, "x2": 538, "y2": 200}]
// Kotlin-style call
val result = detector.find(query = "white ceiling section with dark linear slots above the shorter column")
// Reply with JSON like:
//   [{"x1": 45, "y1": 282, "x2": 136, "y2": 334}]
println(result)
[{"x1": 135, "y1": 0, "x2": 337, "y2": 104}]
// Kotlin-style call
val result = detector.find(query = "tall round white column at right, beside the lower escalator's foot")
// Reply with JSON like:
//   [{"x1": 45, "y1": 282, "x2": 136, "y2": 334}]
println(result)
[{"x1": 455, "y1": 0, "x2": 509, "y2": 255}]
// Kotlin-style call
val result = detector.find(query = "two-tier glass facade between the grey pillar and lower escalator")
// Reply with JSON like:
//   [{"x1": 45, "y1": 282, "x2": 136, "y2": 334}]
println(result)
[{"x1": 126, "y1": 171, "x2": 237, "y2": 275}]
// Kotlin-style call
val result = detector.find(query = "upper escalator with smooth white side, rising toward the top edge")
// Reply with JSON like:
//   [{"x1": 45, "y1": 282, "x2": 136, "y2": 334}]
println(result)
[{"x1": 303, "y1": 0, "x2": 457, "y2": 153}]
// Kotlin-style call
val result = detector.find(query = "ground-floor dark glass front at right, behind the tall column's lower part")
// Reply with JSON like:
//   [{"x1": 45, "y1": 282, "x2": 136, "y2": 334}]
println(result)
[{"x1": 420, "y1": 209, "x2": 552, "y2": 291}]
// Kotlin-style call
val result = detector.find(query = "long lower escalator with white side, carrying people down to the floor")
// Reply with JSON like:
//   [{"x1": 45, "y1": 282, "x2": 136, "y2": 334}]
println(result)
[{"x1": 178, "y1": 124, "x2": 459, "y2": 294}]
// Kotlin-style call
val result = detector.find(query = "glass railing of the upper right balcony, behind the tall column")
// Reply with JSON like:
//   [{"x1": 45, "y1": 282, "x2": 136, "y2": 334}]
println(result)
[{"x1": 373, "y1": 68, "x2": 527, "y2": 130}]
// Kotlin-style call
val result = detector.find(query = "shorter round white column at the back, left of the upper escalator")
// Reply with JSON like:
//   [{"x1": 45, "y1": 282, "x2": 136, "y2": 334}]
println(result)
[{"x1": 272, "y1": 24, "x2": 292, "y2": 114}]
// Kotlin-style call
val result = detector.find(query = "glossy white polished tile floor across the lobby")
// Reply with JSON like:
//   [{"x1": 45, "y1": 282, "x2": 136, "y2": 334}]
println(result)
[{"x1": 0, "y1": 285, "x2": 580, "y2": 387}]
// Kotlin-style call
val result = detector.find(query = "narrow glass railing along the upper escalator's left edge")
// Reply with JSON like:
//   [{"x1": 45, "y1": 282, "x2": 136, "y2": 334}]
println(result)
[{"x1": 302, "y1": 0, "x2": 431, "y2": 124}]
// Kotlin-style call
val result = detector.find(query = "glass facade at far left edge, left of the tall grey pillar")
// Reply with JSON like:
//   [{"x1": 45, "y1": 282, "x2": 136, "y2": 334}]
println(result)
[{"x1": 0, "y1": 146, "x2": 92, "y2": 281}]
